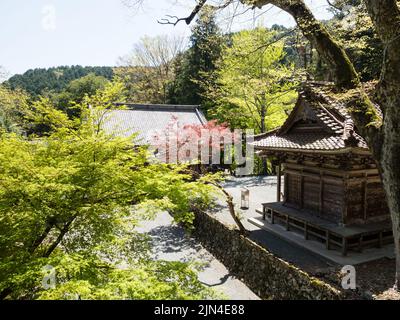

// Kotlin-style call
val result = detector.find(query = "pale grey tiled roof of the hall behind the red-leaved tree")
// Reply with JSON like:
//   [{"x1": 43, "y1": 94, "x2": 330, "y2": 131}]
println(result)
[{"x1": 103, "y1": 103, "x2": 207, "y2": 144}]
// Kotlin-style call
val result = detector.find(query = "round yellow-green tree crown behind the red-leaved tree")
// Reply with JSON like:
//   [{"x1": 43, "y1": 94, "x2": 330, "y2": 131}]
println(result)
[{"x1": 208, "y1": 28, "x2": 297, "y2": 132}]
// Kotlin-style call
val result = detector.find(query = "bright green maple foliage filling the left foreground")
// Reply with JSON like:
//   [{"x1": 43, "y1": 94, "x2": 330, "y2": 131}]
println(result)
[{"x1": 0, "y1": 83, "x2": 219, "y2": 299}]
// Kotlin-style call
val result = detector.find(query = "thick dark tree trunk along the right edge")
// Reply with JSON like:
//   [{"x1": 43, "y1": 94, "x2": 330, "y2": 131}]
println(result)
[{"x1": 364, "y1": 0, "x2": 400, "y2": 290}]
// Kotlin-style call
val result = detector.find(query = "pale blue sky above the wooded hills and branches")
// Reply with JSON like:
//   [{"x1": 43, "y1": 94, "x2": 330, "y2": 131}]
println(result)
[{"x1": 0, "y1": 0, "x2": 329, "y2": 74}]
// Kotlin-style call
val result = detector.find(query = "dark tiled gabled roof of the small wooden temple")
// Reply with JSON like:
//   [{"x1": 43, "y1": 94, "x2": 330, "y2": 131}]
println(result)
[{"x1": 253, "y1": 83, "x2": 372, "y2": 151}]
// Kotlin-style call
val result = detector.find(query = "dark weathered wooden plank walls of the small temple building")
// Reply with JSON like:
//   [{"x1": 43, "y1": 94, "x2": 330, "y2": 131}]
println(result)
[{"x1": 283, "y1": 152, "x2": 389, "y2": 225}]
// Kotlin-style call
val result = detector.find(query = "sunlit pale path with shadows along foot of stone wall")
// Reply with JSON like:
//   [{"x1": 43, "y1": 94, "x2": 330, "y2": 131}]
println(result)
[{"x1": 137, "y1": 213, "x2": 259, "y2": 300}]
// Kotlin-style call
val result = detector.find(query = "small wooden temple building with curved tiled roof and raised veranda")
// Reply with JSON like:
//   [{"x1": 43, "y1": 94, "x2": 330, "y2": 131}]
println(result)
[{"x1": 253, "y1": 83, "x2": 392, "y2": 255}]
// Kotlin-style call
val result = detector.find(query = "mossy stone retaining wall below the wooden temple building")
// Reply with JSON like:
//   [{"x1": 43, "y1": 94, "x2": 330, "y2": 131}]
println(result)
[{"x1": 194, "y1": 212, "x2": 343, "y2": 300}]
